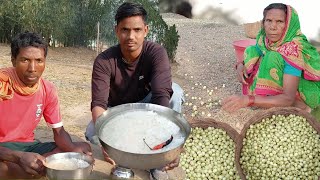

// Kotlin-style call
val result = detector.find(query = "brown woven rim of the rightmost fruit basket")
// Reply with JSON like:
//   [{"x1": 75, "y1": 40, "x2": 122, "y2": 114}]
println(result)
[{"x1": 235, "y1": 107, "x2": 320, "y2": 180}]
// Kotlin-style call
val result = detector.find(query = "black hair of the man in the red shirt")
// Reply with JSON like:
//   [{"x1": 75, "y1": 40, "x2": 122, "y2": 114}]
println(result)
[{"x1": 11, "y1": 31, "x2": 48, "y2": 58}]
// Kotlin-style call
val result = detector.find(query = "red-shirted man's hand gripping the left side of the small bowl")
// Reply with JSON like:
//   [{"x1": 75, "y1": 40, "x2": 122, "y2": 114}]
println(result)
[{"x1": 18, "y1": 152, "x2": 45, "y2": 176}]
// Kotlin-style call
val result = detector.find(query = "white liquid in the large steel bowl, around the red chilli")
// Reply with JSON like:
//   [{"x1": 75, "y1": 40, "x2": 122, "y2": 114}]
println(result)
[{"x1": 100, "y1": 110, "x2": 185, "y2": 154}]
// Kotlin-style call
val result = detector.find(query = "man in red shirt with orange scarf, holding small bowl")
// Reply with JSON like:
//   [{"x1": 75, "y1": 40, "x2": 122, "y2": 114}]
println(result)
[{"x1": 0, "y1": 32, "x2": 92, "y2": 179}]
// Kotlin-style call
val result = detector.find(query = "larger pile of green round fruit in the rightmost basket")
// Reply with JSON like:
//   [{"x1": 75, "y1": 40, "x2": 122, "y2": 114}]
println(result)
[{"x1": 240, "y1": 114, "x2": 320, "y2": 180}]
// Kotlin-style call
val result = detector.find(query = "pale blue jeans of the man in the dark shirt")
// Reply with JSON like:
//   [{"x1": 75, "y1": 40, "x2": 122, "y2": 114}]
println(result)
[{"x1": 85, "y1": 83, "x2": 184, "y2": 145}]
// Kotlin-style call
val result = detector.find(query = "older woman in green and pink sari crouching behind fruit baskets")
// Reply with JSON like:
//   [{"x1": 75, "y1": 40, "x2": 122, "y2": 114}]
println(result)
[{"x1": 222, "y1": 3, "x2": 320, "y2": 112}]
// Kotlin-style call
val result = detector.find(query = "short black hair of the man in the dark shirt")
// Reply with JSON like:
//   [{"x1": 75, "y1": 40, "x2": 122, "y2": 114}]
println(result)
[{"x1": 114, "y1": 2, "x2": 147, "y2": 24}]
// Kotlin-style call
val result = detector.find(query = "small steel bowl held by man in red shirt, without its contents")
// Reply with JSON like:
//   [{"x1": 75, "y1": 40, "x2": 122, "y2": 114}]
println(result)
[{"x1": 45, "y1": 152, "x2": 94, "y2": 180}]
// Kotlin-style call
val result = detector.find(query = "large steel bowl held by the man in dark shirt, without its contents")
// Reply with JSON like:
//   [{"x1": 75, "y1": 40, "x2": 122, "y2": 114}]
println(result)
[{"x1": 95, "y1": 103, "x2": 191, "y2": 170}]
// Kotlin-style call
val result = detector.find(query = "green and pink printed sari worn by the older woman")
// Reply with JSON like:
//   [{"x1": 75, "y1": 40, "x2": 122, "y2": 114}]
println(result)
[{"x1": 243, "y1": 6, "x2": 320, "y2": 109}]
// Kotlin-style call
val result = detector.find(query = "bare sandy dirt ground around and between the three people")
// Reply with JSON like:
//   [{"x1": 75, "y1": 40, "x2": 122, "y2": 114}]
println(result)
[{"x1": 0, "y1": 14, "x2": 255, "y2": 179}]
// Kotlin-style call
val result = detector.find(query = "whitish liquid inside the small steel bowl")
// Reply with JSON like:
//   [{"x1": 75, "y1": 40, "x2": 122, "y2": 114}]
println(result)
[{"x1": 47, "y1": 158, "x2": 90, "y2": 170}]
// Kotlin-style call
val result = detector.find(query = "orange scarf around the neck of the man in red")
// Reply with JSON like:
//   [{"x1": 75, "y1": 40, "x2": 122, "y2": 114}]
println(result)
[{"x1": 0, "y1": 67, "x2": 40, "y2": 102}]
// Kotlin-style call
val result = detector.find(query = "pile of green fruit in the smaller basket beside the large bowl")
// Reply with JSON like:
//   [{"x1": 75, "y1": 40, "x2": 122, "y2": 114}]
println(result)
[{"x1": 180, "y1": 127, "x2": 240, "y2": 180}]
